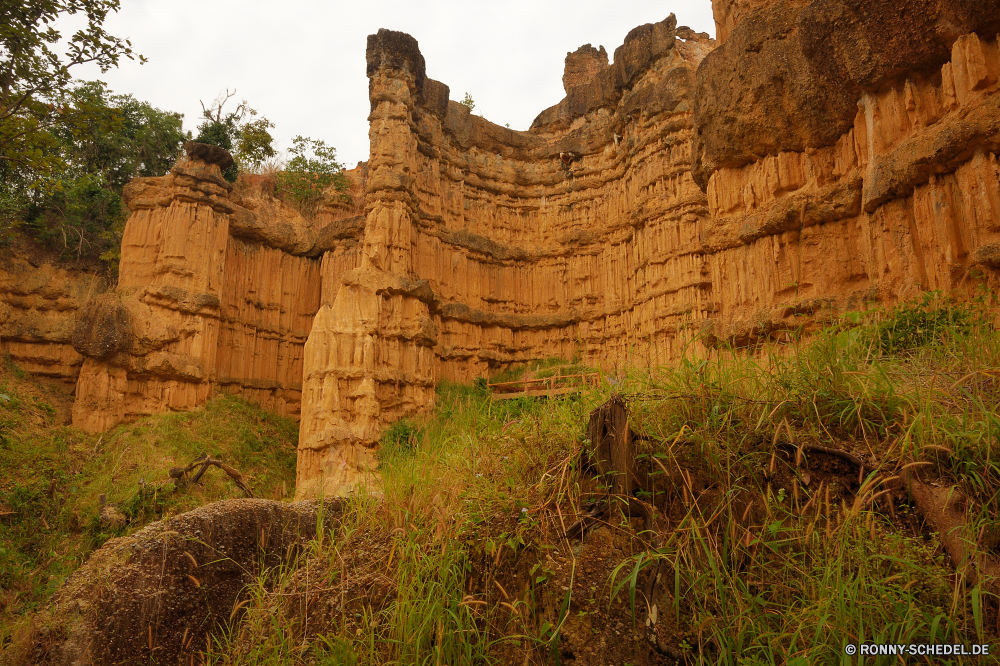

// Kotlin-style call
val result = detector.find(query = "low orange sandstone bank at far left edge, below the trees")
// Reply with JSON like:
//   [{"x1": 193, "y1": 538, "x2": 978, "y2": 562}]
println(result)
[{"x1": 0, "y1": 251, "x2": 105, "y2": 384}]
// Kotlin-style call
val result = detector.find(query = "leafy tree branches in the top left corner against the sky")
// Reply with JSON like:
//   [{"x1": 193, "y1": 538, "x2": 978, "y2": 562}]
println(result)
[{"x1": 0, "y1": 0, "x2": 144, "y2": 186}]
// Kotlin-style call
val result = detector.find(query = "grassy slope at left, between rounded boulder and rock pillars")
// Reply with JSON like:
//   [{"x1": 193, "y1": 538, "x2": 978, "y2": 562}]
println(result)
[{"x1": 0, "y1": 362, "x2": 297, "y2": 639}]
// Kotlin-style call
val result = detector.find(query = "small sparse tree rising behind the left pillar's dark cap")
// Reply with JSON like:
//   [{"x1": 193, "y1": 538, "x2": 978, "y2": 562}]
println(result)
[{"x1": 195, "y1": 90, "x2": 277, "y2": 183}]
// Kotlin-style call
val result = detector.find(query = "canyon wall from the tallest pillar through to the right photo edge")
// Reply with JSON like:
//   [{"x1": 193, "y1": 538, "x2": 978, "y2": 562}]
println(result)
[{"x1": 298, "y1": 0, "x2": 1000, "y2": 496}]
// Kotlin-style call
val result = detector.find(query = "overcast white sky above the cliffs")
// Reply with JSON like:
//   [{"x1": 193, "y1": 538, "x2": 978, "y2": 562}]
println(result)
[{"x1": 68, "y1": 0, "x2": 715, "y2": 167}]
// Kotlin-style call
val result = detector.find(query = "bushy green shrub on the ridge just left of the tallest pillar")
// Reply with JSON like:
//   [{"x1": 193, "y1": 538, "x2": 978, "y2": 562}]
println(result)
[{"x1": 278, "y1": 136, "x2": 351, "y2": 214}]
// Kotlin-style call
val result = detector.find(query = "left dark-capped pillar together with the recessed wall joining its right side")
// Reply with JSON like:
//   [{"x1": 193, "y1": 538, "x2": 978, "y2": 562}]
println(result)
[{"x1": 73, "y1": 143, "x2": 357, "y2": 431}]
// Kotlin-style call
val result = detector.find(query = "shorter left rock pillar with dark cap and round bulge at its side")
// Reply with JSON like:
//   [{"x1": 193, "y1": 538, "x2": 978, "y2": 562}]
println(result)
[{"x1": 73, "y1": 142, "x2": 233, "y2": 432}]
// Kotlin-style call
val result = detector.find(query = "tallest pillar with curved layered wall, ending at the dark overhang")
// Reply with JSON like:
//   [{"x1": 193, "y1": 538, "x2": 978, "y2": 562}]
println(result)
[{"x1": 297, "y1": 16, "x2": 713, "y2": 497}]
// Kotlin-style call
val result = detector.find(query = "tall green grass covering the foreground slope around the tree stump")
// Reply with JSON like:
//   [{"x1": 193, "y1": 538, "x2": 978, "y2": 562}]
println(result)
[{"x1": 1, "y1": 295, "x2": 1000, "y2": 666}]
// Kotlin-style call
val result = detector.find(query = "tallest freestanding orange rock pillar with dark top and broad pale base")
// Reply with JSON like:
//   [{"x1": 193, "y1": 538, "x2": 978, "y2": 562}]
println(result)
[{"x1": 296, "y1": 30, "x2": 437, "y2": 498}]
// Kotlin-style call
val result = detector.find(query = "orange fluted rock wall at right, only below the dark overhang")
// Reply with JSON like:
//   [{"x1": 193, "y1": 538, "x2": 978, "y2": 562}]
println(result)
[{"x1": 704, "y1": 14, "x2": 1000, "y2": 345}]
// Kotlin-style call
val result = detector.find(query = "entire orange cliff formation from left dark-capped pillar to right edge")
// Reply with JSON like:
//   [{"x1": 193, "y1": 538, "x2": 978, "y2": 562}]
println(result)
[{"x1": 73, "y1": 0, "x2": 1000, "y2": 498}]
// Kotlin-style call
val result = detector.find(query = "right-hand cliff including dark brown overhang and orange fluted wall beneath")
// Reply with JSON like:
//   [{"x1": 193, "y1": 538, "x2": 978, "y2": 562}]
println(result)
[{"x1": 694, "y1": 0, "x2": 1000, "y2": 344}]
